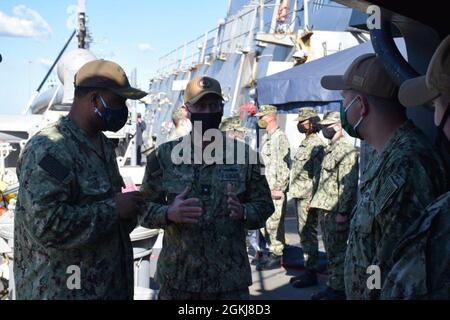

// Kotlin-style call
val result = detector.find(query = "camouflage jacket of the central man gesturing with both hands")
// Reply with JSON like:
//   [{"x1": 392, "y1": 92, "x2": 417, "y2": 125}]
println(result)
[{"x1": 139, "y1": 135, "x2": 274, "y2": 293}]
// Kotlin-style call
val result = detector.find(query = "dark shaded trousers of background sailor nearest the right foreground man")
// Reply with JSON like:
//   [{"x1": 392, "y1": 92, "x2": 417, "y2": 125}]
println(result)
[{"x1": 318, "y1": 210, "x2": 350, "y2": 290}]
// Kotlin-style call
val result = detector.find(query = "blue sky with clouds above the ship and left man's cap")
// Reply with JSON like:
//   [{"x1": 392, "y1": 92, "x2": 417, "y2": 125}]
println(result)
[{"x1": 0, "y1": 0, "x2": 228, "y2": 114}]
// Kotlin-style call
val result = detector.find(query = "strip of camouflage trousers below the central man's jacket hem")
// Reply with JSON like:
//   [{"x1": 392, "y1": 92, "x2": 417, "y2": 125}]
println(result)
[{"x1": 158, "y1": 285, "x2": 250, "y2": 301}]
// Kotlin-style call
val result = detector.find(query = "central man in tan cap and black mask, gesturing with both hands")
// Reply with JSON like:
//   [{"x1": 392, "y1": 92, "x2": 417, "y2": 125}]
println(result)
[{"x1": 139, "y1": 77, "x2": 274, "y2": 300}]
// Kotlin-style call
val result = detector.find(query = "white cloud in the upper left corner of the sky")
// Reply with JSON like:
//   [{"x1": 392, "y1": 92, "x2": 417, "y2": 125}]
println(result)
[{"x1": 0, "y1": 5, "x2": 52, "y2": 39}]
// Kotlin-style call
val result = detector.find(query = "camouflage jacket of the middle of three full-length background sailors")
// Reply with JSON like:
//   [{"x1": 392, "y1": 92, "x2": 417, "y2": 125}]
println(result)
[{"x1": 289, "y1": 134, "x2": 326, "y2": 201}]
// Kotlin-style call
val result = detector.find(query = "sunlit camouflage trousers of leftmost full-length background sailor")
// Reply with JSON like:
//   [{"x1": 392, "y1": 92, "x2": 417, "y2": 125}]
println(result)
[{"x1": 261, "y1": 196, "x2": 286, "y2": 256}]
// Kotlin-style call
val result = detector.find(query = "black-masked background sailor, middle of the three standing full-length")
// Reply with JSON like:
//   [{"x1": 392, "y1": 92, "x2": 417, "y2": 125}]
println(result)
[{"x1": 289, "y1": 107, "x2": 326, "y2": 288}]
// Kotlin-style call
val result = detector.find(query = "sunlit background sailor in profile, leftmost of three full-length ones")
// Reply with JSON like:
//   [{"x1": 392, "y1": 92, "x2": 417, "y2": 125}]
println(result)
[{"x1": 255, "y1": 105, "x2": 291, "y2": 271}]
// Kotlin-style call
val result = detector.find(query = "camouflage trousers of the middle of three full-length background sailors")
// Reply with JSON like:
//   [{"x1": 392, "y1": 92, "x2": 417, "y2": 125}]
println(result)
[{"x1": 295, "y1": 199, "x2": 319, "y2": 270}]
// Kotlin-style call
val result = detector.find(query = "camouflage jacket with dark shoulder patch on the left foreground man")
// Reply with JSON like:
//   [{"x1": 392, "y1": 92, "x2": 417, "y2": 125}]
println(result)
[{"x1": 14, "y1": 117, "x2": 137, "y2": 300}]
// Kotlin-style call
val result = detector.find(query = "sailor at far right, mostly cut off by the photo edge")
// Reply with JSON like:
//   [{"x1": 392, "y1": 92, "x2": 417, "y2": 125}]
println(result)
[{"x1": 381, "y1": 36, "x2": 450, "y2": 300}]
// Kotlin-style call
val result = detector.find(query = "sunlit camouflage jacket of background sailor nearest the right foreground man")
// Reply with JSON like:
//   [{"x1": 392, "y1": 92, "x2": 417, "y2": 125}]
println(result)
[{"x1": 310, "y1": 137, "x2": 359, "y2": 214}]
